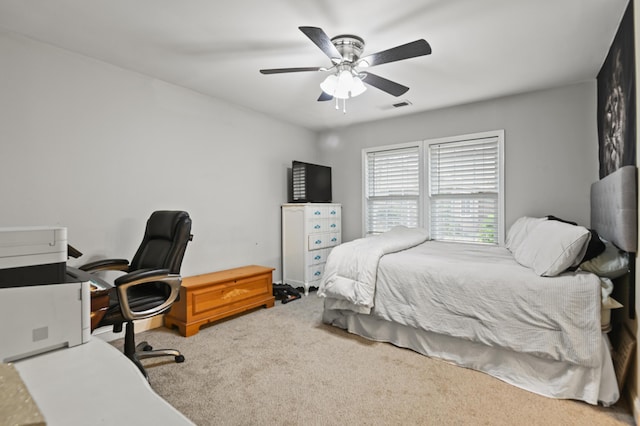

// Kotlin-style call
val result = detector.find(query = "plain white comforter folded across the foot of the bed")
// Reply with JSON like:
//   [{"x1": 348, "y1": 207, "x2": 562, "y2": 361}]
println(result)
[{"x1": 318, "y1": 226, "x2": 427, "y2": 313}]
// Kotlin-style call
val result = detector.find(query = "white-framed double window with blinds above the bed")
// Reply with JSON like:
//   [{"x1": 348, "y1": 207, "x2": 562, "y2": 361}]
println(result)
[{"x1": 363, "y1": 130, "x2": 504, "y2": 245}]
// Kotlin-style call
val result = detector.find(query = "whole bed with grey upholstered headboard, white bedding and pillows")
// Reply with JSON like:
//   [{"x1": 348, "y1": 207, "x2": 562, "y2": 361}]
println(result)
[{"x1": 318, "y1": 166, "x2": 637, "y2": 406}]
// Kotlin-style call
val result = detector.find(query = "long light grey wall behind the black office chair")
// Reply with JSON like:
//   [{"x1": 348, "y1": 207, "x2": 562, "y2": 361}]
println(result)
[{"x1": 0, "y1": 33, "x2": 318, "y2": 280}]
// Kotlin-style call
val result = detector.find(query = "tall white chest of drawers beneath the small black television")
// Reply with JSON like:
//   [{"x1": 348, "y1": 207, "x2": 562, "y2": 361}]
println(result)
[{"x1": 282, "y1": 203, "x2": 342, "y2": 295}]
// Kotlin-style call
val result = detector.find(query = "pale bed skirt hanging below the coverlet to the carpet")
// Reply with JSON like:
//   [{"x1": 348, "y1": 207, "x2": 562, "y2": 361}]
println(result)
[{"x1": 323, "y1": 309, "x2": 620, "y2": 406}]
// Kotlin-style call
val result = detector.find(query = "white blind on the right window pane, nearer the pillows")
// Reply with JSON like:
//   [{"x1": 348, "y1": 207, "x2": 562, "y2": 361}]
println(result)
[{"x1": 428, "y1": 137, "x2": 500, "y2": 244}]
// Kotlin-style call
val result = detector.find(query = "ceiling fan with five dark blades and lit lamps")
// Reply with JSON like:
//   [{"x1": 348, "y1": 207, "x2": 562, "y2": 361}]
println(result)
[{"x1": 260, "y1": 27, "x2": 431, "y2": 112}]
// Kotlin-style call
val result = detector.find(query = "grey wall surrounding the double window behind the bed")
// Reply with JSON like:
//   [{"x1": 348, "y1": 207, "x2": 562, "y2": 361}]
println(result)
[{"x1": 320, "y1": 80, "x2": 598, "y2": 241}]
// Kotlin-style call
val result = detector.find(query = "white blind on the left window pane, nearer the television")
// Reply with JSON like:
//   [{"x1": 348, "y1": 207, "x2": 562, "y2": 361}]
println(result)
[{"x1": 365, "y1": 146, "x2": 420, "y2": 234}]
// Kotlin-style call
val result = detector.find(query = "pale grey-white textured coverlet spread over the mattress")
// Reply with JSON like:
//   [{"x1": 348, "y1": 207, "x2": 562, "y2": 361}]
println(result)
[{"x1": 325, "y1": 241, "x2": 602, "y2": 367}]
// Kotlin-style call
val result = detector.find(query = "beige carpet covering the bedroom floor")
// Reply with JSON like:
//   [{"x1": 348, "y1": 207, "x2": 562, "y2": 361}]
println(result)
[{"x1": 114, "y1": 293, "x2": 633, "y2": 426}]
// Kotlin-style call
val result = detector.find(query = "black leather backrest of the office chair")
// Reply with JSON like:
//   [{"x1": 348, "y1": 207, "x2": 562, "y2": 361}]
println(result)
[{"x1": 129, "y1": 210, "x2": 192, "y2": 274}]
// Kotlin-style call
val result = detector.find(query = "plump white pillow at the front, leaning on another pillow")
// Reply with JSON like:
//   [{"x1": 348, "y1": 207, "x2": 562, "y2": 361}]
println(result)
[{"x1": 513, "y1": 220, "x2": 591, "y2": 277}]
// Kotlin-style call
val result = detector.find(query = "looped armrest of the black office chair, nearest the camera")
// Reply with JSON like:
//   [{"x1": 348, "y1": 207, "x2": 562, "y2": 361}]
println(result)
[{"x1": 115, "y1": 269, "x2": 182, "y2": 321}]
